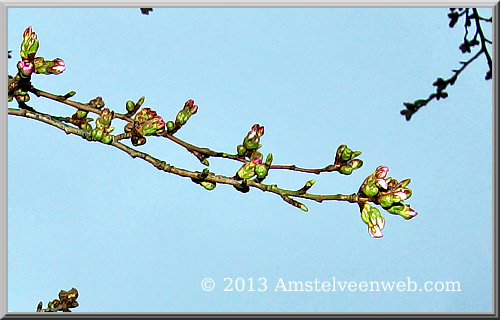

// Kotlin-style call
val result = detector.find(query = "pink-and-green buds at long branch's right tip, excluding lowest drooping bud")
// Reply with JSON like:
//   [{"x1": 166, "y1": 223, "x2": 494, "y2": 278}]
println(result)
[{"x1": 359, "y1": 166, "x2": 418, "y2": 219}]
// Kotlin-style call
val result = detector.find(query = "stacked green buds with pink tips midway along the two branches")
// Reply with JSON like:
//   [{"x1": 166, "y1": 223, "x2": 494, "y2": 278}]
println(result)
[{"x1": 235, "y1": 124, "x2": 273, "y2": 182}]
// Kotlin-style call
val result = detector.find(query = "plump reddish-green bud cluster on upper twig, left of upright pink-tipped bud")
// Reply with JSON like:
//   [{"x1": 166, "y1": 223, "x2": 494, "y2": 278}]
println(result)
[{"x1": 124, "y1": 108, "x2": 165, "y2": 146}]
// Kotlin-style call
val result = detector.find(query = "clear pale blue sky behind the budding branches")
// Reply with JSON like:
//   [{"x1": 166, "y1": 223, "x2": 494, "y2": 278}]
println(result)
[{"x1": 8, "y1": 8, "x2": 492, "y2": 312}]
